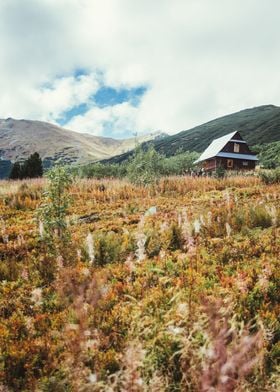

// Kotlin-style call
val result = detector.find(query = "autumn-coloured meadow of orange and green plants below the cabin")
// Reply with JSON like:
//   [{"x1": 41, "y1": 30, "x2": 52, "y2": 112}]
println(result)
[{"x1": 0, "y1": 177, "x2": 280, "y2": 392}]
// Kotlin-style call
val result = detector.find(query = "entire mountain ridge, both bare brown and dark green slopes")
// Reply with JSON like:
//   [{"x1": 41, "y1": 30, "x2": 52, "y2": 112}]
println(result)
[{"x1": 0, "y1": 105, "x2": 280, "y2": 178}]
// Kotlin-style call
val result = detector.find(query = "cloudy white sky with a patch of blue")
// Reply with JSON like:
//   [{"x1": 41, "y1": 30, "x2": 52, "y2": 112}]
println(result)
[{"x1": 0, "y1": 0, "x2": 280, "y2": 138}]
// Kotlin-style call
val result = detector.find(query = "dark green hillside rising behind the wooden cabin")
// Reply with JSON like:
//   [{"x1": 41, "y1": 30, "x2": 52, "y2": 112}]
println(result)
[{"x1": 103, "y1": 105, "x2": 280, "y2": 162}]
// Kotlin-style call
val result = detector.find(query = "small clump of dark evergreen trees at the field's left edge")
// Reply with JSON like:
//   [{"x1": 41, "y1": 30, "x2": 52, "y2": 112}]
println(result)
[{"x1": 9, "y1": 152, "x2": 43, "y2": 180}]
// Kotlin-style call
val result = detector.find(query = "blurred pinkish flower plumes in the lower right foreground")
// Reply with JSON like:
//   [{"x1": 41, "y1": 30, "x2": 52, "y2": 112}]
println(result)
[{"x1": 200, "y1": 302, "x2": 263, "y2": 391}]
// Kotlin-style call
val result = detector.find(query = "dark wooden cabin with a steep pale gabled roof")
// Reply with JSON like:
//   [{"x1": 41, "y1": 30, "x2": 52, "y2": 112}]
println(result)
[{"x1": 195, "y1": 131, "x2": 258, "y2": 172}]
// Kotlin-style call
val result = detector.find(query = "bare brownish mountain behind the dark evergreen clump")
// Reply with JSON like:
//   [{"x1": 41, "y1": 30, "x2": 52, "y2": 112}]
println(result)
[{"x1": 0, "y1": 118, "x2": 164, "y2": 177}]
